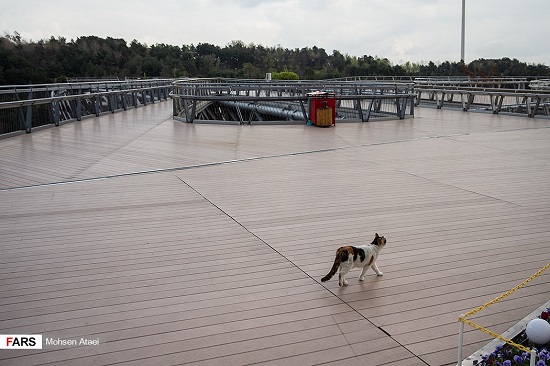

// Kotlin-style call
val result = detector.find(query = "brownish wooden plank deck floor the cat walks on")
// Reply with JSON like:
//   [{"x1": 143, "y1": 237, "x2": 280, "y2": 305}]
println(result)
[{"x1": 0, "y1": 103, "x2": 550, "y2": 366}]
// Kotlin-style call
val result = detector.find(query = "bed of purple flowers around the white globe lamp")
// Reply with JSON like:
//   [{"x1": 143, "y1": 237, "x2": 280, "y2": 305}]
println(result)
[{"x1": 473, "y1": 308, "x2": 550, "y2": 366}]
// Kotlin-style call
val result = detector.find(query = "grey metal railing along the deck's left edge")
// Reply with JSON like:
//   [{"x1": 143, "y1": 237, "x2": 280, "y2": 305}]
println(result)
[{"x1": 0, "y1": 79, "x2": 173, "y2": 134}]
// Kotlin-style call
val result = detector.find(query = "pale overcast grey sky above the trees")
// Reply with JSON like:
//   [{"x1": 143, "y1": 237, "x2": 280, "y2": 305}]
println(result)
[{"x1": 0, "y1": 0, "x2": 550, "y2": 66}]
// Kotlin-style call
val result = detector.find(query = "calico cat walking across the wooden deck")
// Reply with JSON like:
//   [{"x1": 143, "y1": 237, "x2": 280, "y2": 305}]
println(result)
[{"x1": 321, "y1": 234, "x2": 386, "y2": 286}]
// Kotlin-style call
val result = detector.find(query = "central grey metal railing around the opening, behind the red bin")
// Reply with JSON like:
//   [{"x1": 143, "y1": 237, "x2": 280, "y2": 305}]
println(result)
[{"x1": 171, "y1": 79, "x2": 414, "y2": 124}]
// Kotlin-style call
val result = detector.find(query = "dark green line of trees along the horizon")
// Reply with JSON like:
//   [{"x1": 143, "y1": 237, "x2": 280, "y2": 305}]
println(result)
[{"x1": 0, "y1": 32, "x2": 550, "y2": 85}]
